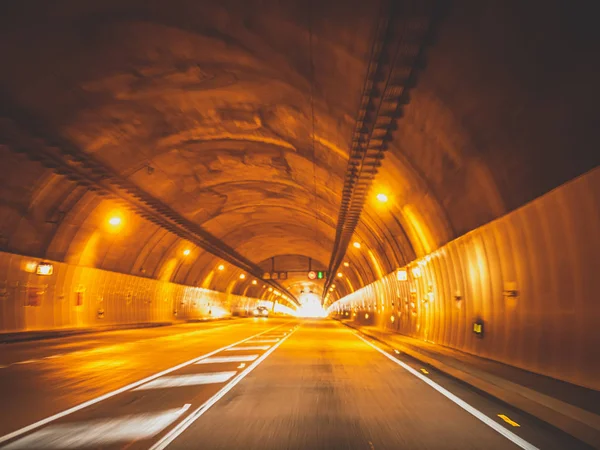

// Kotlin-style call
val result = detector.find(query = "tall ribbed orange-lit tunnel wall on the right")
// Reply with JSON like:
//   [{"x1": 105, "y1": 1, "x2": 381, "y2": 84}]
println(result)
[{"x1": 332, "y1": 168, "x2": 600, "y2": 389}]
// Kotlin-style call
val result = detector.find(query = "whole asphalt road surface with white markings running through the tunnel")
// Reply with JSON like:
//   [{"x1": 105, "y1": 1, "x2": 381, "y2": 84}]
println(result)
[{"x1": 0, "y1": 319, "x2": 585, "y2": 450}]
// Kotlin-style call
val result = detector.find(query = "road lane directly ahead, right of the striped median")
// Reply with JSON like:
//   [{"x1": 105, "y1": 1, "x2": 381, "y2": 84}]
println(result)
[{"x1": 169, "y1": 321, "x2": 579, "y2": 450}]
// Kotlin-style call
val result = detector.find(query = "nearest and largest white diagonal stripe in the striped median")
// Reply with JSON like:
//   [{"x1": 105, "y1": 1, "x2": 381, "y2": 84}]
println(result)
[{"x1": 2, "y1": 403, "x2": 192, "y2": 450}]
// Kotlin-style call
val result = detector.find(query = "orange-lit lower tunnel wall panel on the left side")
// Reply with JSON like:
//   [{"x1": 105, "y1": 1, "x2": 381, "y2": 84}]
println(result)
[{"x1": 0, "y1": 252, "x2": 259, "y2": 332}]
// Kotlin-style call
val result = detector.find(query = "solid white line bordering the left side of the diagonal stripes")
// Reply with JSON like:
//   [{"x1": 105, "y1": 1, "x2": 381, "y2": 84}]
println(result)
[{"x1": 0, "y1": 324, "x2": 292, "y2": 444}]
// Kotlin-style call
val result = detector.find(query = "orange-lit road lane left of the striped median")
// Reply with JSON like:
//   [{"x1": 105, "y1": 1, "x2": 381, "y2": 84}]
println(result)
[{"x1": 0, "y1": 319, "x2": 288, "y2": 436}]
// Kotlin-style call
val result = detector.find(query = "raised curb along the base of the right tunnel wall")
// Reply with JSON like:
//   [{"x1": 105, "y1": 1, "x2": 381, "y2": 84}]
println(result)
[{"x1": 339, "y1": 321, "x2": 600, "y2": 448}]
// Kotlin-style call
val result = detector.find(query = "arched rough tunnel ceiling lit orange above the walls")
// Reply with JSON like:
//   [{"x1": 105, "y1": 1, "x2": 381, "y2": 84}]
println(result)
[{"x1": 0, "y1": 1, "x2": 599, "y2": 302}]
